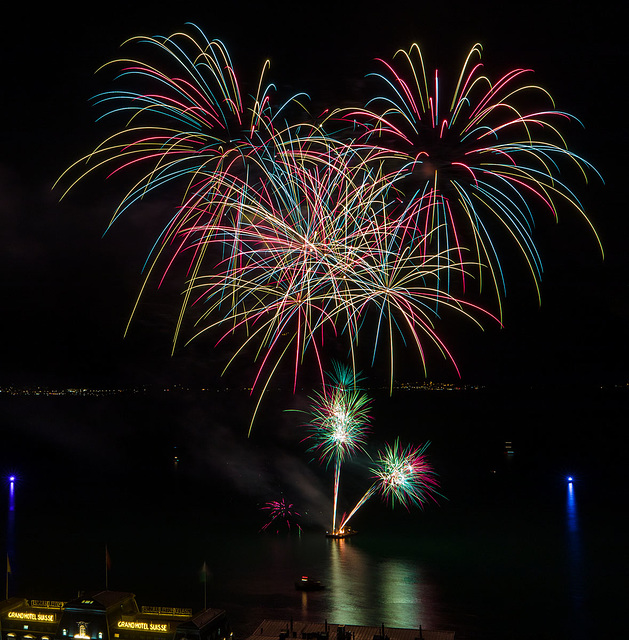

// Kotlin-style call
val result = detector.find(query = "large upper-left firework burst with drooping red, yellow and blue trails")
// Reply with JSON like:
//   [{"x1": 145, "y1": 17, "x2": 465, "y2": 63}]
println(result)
[{"x1": 59, "y1": 25, "x2": 306, "y2": 210}]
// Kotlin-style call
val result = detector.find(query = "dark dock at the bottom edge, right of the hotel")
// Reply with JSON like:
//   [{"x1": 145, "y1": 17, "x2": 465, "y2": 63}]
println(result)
[{"x1": 247, "y1": 619, "x2": 454, "y2": 640}]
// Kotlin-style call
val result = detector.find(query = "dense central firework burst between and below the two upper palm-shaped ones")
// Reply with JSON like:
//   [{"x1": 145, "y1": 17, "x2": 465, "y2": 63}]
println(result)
[{"x1": 182, "y1": 139, "x2": 490, "y2": 424}]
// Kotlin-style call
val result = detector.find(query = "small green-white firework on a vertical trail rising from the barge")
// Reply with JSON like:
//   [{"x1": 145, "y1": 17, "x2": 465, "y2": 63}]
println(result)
[{"x1": 308, "y1": 363, "x2": 371, "y2": 531}]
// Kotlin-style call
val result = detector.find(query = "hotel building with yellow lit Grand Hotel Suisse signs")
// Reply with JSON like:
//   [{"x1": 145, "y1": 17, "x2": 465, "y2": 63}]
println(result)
[{"x1": 0, "y1": 591, "x2": 231, "y2": 640}]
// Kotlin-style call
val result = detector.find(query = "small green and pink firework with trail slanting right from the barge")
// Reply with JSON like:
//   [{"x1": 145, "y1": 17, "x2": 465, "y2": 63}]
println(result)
[{"x1": 339, "y1": 440, "x2": 439, "y2": 529}]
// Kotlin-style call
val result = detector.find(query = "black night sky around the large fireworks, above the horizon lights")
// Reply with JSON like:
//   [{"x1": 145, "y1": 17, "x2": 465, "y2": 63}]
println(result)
[{"x1": 0, "y1": 0, "x2": 629, "y2": 385}]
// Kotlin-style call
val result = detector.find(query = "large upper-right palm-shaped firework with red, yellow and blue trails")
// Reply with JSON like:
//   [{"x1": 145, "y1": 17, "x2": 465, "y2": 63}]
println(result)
[{"x1": 332, "y1": 44, "x2": 598, "y2": 316}]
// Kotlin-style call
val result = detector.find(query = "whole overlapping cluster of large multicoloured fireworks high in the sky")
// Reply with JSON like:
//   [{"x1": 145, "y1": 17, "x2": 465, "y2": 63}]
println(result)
[{"x1": 55, "y1": 26, "x2": 592, "y2": 424}]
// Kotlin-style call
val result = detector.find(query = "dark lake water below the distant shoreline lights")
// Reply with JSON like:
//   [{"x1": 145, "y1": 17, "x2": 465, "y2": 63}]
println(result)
[{"x1": 0, "y1": 390, "x2": 629, "y2": 640}]
